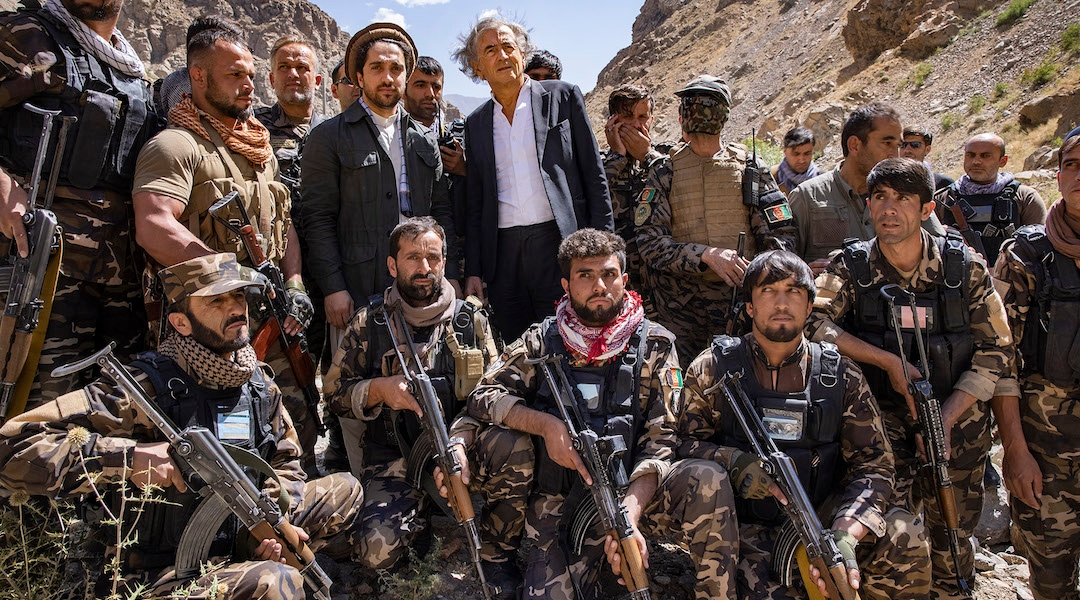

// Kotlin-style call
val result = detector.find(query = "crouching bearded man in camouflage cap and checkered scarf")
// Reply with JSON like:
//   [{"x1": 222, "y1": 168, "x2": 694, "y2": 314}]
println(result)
[{"x1": 0, "y1": 254, "x2": 363, "y2": 600}]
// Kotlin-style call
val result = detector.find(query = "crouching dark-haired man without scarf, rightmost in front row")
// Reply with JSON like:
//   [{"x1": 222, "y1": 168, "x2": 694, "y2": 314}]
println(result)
[{"x1": 679, "y1": 251, "x2": 930, "y2": 600}]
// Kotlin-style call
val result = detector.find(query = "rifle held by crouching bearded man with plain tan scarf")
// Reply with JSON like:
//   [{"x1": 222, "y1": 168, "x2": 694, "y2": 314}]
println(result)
[{"x1": 375, "y1": 305, "x2": 500, "y2": 600}]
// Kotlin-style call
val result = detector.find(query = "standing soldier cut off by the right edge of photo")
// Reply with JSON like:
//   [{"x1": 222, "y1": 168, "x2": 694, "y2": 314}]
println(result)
[{"x1": 994, "y1": 135, "x2": 1080, "y2": 600}]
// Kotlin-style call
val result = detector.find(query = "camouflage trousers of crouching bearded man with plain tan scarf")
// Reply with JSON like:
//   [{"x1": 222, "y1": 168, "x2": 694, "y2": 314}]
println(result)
[{"x1": 349, "y1": 427, "x2": 534, "y2": 569}]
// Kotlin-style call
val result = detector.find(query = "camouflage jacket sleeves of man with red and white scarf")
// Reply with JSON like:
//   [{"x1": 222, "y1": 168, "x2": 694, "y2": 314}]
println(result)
[{"x1": 467, "y1": 322, "x2": 683, "y2": 481}]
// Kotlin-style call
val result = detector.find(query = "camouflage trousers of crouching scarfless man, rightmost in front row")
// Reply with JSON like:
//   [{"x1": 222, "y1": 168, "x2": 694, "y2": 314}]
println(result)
[{"x1": 738, "y1": 507, "x2": 930, "y2": 600}]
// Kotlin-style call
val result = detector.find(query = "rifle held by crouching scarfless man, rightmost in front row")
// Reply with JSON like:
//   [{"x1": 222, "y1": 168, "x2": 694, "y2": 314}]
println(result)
[{"x1": 719, "y1": 372, "x2": 859, "y2": 600}]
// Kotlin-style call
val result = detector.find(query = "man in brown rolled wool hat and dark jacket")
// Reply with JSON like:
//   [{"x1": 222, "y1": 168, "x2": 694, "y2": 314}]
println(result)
[{"x1": 300, "y1": 23, "x2": 459, "y2": 349}]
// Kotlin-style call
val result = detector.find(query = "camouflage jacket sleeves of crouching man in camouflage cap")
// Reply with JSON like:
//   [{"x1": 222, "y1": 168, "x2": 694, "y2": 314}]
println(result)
[{"x1": 0, "y1": 358, "x2": 306, "y2": 508}]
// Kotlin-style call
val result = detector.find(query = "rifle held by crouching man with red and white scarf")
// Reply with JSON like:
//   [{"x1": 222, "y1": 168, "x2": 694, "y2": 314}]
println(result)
[{"x1": 525, "y1": 354, "x2": 651, "y2": 600}]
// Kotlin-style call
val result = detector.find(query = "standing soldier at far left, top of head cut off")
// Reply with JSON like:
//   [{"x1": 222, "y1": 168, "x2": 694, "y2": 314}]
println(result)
[{"x1": 0, "y1": 0, "x2": 161, "y2": 399}]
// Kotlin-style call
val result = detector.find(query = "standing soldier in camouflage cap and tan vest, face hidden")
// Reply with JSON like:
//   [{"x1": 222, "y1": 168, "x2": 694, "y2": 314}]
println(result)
[{"x1": 634, "y1": 76, "x2": 795, "y2": 360}]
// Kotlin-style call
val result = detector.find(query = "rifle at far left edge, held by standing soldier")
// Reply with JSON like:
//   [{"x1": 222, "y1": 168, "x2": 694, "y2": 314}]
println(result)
[{"x1": 0, "y1": 104, "x2": 76, "y2": 423}]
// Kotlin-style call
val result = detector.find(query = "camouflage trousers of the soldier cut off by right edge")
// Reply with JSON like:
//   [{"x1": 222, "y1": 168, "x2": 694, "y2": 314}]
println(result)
[{"x1": 1012, "y1": 378, "x2": 1080, "y2": 600}]
